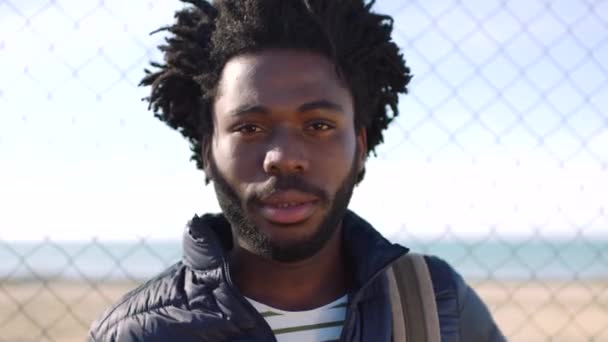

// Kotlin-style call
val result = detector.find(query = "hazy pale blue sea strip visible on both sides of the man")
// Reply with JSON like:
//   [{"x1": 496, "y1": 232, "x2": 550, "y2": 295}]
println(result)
[{"x1": 0, "y1": 237, "x2": 608, "y2": 283}]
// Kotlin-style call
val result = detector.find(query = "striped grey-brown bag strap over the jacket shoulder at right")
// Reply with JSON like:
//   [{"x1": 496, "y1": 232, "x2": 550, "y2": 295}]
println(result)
[{"x1": 386, "y1": 253, "x2": 441, "y2": 342}]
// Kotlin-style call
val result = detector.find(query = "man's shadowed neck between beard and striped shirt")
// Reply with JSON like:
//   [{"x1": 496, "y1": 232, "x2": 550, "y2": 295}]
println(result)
[{"x1": 230, "y1": 225, "x2": 346, "y2": 311}]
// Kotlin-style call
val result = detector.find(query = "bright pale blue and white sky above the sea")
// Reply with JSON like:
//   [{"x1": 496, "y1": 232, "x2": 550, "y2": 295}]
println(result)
[{"x1": 0, "y1": 0, "x2": 608, "y2": 240}]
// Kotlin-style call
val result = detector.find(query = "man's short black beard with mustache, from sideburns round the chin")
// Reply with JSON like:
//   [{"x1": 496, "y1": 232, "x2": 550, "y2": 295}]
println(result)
[{"x1": 209, "y1": 148, "x2": 359, "y2": 263}]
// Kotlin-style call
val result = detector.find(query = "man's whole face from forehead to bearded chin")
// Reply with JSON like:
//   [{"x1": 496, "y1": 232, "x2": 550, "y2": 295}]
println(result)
[{"x1": 205, "y1": 50, "x2": 366, "y2": 262}]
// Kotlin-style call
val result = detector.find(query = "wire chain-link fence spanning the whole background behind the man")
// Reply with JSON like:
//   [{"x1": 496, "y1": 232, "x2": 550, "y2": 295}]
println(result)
[{"x1": 0, "y1": 0, "x2": 608, "y2": 341}]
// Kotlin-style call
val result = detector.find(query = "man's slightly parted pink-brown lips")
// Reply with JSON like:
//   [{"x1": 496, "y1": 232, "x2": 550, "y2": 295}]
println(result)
[{"x1": 260, "y1": 190, "x2": 319, "y2": 225}]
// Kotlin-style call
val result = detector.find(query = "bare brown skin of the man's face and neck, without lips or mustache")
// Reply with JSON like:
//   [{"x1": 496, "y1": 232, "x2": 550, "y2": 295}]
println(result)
[{"x1": 205, "y1": 49, "x2": 367, "y2": 311}]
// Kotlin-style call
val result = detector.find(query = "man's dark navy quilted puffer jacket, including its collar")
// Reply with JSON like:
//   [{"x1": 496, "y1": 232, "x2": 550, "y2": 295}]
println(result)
[{"x1": 89, "y1": 211, "x2": 504, "y2": 342}]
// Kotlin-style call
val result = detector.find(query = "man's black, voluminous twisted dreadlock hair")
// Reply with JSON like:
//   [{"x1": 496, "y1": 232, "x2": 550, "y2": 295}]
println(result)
[{"x1": 140, "y1": 0, "x2": 411, "y2": 183}]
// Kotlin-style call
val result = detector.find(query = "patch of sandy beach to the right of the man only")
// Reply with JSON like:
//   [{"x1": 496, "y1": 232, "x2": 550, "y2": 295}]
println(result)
[{"x1": 472, "y1": 280, "x2": 608, "y2": 342}]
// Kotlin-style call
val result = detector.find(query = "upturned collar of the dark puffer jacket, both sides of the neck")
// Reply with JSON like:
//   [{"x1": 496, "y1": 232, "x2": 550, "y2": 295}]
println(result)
[{"x1": 183, "y1": 210, "x2": 408, "y2": 288}]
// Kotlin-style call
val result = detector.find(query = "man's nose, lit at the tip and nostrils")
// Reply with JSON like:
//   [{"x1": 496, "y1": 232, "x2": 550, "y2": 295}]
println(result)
[{"x1": 264, "y1": 132, "x2": 310, "y2": 175}]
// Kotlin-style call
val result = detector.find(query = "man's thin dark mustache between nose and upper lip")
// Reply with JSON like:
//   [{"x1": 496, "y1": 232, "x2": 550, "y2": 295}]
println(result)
[{"x1": 247, "y1": 175, "x2": 329, "y2": 203}]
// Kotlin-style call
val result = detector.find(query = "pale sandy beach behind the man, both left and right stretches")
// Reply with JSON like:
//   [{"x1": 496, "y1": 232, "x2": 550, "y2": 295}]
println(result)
[{"x1": 0, "y1": 280, "x2": 608, "y2": 342}]
